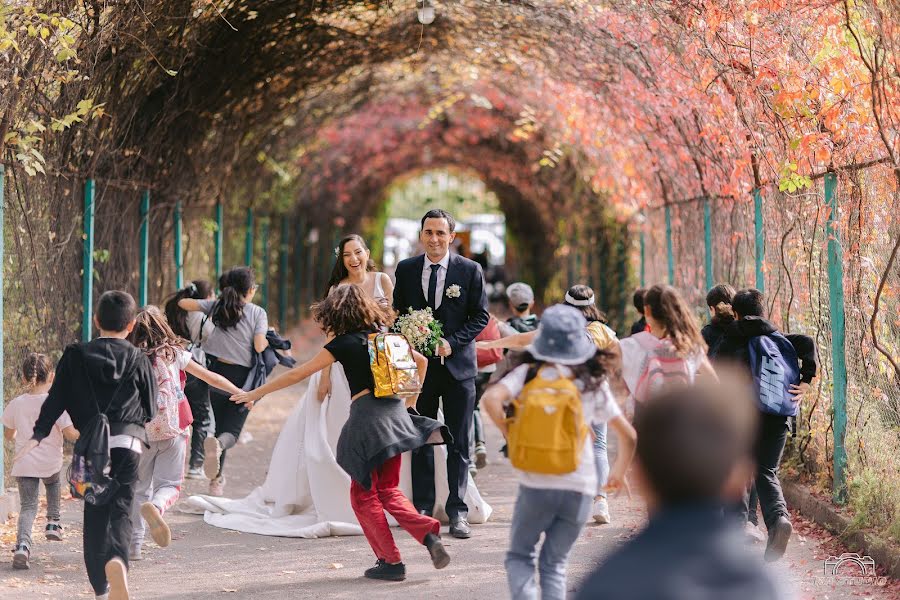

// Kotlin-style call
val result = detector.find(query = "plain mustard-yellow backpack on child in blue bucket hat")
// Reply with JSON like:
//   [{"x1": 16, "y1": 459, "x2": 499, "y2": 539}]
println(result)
[{"x1": 508, "y1": 367, "x2": 587, "y2": 475}]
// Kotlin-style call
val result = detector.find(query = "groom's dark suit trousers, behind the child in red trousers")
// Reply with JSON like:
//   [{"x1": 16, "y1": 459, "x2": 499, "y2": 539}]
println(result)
[{"x1": 412, "y1": 359, "x2": 475, "y2": 520}]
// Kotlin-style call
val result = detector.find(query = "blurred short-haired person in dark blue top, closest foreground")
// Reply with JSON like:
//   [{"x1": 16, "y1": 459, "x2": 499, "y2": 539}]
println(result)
[{"x1": 576, "y1": 379, "x2": 793, "y2": 600}]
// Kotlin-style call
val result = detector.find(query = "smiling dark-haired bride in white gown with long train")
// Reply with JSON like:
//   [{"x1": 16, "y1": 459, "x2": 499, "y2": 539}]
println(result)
[{"x1": 187, "y1": 234, "x2": 492, "y2": 538}]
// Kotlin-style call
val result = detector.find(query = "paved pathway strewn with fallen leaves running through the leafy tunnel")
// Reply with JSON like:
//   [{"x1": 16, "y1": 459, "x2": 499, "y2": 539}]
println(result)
[{"x1": 0, "y1": 326, "x2": 897, "y2": 600}]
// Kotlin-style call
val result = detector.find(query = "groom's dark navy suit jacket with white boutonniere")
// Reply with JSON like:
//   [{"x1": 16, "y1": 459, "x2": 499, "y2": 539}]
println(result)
[{"x1": 394, "y1": 253, "x2": 489, "y2": 381}]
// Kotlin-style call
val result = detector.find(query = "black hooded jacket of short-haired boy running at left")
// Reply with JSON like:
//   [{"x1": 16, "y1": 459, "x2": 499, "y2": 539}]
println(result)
[{"x1": 32, "y1": 338, "x2": 157, "y2": 445}]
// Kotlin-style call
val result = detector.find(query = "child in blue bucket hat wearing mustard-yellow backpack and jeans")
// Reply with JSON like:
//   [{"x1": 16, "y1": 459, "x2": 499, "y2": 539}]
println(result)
[{"x1": 483, "y1": 305, "x2": 636, "y2": 600}]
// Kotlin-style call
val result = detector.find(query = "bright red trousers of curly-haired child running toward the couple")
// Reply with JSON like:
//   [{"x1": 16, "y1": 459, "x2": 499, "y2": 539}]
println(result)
[{"x1": 350, "y1": 454, "x2": 441, "y2": 564}]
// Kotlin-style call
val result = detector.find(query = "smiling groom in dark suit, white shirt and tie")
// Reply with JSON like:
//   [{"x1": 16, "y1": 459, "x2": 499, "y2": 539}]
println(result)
[{"x1": 394, "y1": 209, "x2": 488, "y2": 538}]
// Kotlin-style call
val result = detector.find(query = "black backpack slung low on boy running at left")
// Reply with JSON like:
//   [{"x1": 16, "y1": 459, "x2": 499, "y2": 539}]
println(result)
[{"x1": 67, "y1": 350, "x2": 135, "y2": 505}]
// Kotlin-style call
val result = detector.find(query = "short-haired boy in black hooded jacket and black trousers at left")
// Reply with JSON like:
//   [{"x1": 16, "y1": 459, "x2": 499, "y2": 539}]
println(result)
[{"x1": 16, "y1": 291, "x2": 156, "y2": 600}]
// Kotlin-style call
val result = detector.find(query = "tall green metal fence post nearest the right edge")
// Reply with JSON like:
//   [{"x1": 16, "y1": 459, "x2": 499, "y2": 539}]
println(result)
[{"x1": 825, "y1": 173, "x2": 847, "y2": 502}]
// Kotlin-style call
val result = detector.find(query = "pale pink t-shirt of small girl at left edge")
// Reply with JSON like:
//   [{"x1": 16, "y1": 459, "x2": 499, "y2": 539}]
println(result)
[{"x1": 3, "y1": 394, "x2": 72, "y2": 477}]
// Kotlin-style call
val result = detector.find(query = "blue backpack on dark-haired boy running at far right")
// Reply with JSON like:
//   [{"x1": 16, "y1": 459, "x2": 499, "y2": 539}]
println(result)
[{"x1": 748, "y1": 332, "x2": 800, "y2": 417}]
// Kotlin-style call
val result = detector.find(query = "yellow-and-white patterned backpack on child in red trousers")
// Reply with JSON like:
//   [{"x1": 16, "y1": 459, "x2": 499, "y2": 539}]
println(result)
[{"x1": 369, "y1": 333, "x2": 422, "y2": 398}]
